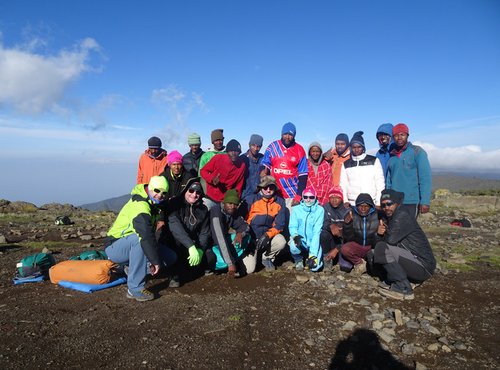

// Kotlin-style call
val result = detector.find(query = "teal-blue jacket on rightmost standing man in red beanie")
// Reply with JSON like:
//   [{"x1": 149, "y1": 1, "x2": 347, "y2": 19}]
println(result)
[{"x1": 385, "y1": 142, "x2": 432, "y2": 205}]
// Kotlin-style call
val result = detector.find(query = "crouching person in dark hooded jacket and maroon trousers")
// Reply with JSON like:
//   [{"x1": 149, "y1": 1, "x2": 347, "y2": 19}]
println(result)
[{"x1": 339, "y1": 193, "x2": 378, "y2": 275}]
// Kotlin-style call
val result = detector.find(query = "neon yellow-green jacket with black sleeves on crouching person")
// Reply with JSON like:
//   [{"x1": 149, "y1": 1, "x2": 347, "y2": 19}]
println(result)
[{"x1": 106, "y1": 184, "x2": 161, "y2": 265}]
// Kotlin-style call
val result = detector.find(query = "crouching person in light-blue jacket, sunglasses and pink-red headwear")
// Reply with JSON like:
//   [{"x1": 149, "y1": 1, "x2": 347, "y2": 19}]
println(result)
[{"x1": 288, "y1": 187, "x2": 325, "y2": 272}]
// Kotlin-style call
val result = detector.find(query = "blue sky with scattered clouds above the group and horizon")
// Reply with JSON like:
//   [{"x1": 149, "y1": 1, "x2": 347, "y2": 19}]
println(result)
[{"x1": 0, "y1": 0, "x2": 500, "y2": 206}]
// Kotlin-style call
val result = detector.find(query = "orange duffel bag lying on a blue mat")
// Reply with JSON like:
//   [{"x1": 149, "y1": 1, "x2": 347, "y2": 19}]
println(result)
[{"x1": 49, "y1": 260, "x2": 117, "y2": 284}]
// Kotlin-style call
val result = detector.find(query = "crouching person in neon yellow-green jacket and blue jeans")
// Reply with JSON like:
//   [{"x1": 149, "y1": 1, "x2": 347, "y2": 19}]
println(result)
[{"x1": 105, "y1": 176, "x2": 177, "y2": 302}]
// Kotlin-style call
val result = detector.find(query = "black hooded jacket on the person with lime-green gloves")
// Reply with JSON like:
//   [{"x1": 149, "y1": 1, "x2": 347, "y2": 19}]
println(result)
[{"x1": 167, "y1": 178, "x2": 211, "y2": 250}]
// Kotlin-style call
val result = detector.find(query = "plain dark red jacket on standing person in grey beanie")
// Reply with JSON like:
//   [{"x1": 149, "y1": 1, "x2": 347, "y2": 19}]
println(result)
[{"x1": 200, "y1": 154, "x2": 245, "y2": 202}]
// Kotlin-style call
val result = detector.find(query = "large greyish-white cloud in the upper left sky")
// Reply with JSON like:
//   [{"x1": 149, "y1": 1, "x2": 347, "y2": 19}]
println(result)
[{"x1": 0, "y1": 38, "x2": 100, "y2": 114}]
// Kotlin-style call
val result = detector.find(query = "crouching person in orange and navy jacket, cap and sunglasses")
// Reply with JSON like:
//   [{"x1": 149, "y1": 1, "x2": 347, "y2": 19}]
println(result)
[{"x1": 246, "y1": 176, "x2": 287, "y2": 272}]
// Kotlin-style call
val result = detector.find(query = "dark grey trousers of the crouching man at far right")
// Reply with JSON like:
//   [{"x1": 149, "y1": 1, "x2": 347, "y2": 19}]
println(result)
[{"x1": 374, "y1": 242, "x2": 431, "y2": 288}]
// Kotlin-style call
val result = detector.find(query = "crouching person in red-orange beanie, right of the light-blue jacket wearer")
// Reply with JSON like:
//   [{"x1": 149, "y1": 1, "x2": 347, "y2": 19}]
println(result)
[{"x1": 320, "y1": 186, "x2": 350, "y2": 269}]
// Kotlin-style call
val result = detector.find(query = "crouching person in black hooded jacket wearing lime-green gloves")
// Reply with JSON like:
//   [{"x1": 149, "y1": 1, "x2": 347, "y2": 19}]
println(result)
[{"x1": 165, "y1": 177, "x2": 215, "y2": 288}]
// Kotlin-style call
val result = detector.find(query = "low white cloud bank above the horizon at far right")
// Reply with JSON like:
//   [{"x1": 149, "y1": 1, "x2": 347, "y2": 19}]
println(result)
[{"x1": 415, "y1": 141, "x2": 500, "y2": 174}]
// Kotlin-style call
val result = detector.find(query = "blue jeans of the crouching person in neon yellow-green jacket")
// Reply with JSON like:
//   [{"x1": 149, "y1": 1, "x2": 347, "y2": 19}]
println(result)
[{"x1": 105, "y1": 234, "x2": 177, "y2": 293}]
